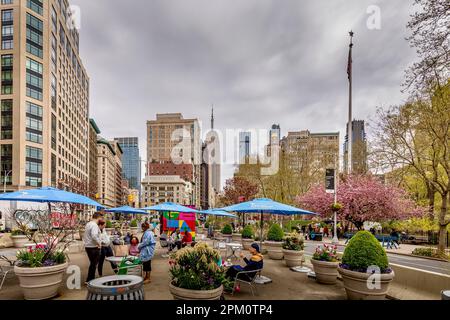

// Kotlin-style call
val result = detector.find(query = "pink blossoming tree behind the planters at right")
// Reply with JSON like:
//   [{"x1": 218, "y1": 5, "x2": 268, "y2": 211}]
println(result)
[{"x1": 297, "y1": 175, "x2": 424, "y2": 230}]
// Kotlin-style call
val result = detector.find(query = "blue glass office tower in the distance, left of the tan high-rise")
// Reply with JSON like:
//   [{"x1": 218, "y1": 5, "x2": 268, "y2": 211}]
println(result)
[{"x1": 114, "y1": 138, "x2": 141, "y2": 190}]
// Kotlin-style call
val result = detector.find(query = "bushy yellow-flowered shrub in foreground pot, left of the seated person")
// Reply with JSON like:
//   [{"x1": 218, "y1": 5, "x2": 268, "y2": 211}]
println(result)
[{"x1": 169, "y1": 243, "x2": 225, "y2": 300}]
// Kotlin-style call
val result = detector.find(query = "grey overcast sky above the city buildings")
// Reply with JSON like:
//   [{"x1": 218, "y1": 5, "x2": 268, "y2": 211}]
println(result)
[{"x1": 71, "y1": 0, "x2": 415, "y2": 186}]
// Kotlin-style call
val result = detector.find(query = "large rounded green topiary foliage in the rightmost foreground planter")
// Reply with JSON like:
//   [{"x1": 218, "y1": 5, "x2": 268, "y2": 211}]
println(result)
[{"x1": 342, "y1": 231, "x2": 389, "y2": 272}]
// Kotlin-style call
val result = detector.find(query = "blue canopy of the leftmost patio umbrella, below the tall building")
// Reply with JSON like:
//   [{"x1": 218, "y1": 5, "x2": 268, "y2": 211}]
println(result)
[{"x1": 0, "y1": 187, "x2": 104, "y2": 208}]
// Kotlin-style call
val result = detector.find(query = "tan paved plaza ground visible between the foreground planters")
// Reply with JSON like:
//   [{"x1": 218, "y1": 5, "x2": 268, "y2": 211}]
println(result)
[{"x1": 0, "y1": 239, "x2": 346, "y2": 300}]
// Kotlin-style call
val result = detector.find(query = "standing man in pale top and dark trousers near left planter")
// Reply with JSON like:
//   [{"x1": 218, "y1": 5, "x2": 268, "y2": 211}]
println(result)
[{"x1": 84, "y1": 212, "x2": 102, "y2": 283}]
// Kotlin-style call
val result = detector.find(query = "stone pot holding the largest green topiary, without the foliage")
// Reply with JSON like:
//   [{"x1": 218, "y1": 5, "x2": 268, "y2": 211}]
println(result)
[{"x1": 338, "y1": 268, "x2": 395, "y2": 300}]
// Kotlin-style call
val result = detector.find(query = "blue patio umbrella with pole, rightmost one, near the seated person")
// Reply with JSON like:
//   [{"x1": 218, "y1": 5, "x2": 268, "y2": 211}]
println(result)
[{"x1": 221, "y1": 198, "x2": 317, "y2": 248}]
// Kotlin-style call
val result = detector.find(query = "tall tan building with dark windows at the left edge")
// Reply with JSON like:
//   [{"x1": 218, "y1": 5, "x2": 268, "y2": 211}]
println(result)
[{"x1": 0, "y1": 0, "x2": 89, "y2": 191}]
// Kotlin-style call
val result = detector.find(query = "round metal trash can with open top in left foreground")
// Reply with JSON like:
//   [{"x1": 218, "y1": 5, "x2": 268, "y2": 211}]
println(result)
[{"x1": 86, "y1": 275, "x2": 145, "y2": 300}]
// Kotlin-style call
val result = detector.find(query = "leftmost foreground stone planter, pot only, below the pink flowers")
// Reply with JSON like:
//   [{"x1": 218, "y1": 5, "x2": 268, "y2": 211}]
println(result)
[{"x1": 14, "y1": 262, "x2": 69, "y2": 300}]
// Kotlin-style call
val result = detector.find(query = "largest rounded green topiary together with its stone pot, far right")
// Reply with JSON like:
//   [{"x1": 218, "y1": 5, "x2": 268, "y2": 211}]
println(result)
[{"x1": 338, "y1": 231, "x2": 395, "y2": 300}]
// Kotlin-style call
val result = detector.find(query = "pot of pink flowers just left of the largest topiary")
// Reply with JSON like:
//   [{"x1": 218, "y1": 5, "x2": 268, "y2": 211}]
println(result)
[{"x1": 311, "y1": 244, "x2": 339, "y2": 284}]
